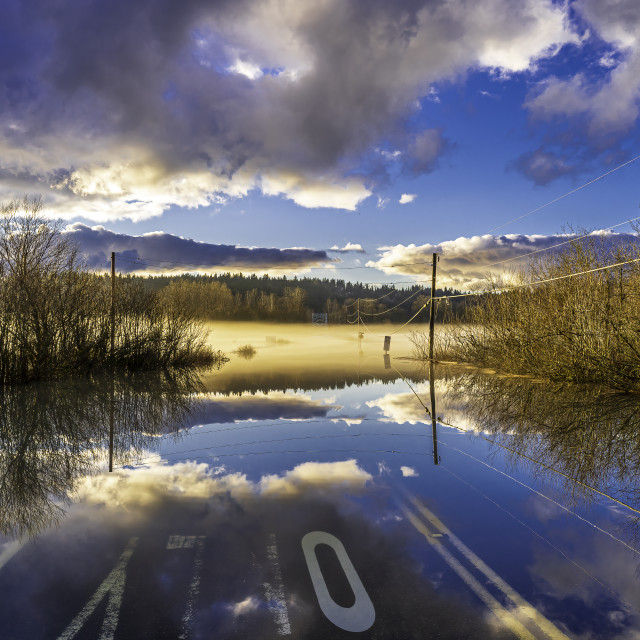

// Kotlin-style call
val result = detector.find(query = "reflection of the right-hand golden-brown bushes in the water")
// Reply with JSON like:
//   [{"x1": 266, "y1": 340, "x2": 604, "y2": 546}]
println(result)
[{"x1": 447, "y1": 374, "x2": 640, "y2": 506}]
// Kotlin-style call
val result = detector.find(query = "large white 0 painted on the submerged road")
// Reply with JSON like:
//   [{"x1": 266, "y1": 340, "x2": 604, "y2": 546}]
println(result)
[{"x1": 302, "y1": 531, "x2": 376, "y2": 632}]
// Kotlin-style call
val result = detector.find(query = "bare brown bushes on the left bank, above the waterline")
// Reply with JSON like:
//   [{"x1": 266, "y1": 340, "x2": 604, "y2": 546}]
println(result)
[{"x1": 0, "y1": 198, "x2": 223, "y2": 384}]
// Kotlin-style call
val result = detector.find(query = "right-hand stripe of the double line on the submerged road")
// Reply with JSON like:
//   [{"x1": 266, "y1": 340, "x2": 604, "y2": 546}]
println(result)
[{"x1": 402, "y1": 494, "x2": 569, "y2": 640}]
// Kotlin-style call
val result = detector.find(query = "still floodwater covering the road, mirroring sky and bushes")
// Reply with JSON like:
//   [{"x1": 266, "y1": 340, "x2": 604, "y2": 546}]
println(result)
[{"x1": 0, "y1": 323, "x2": 640, "y2": 640}]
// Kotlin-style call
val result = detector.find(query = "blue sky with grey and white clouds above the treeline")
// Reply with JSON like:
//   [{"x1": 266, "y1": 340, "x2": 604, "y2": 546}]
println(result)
[{"x1": 0, "y1": 0, "x2": 640, "y2": 288}]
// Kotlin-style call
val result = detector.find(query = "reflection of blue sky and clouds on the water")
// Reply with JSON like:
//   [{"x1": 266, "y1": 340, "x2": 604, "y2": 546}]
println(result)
[{"x1": 0, "y1": 352, "x2": 640, "y2": 640}]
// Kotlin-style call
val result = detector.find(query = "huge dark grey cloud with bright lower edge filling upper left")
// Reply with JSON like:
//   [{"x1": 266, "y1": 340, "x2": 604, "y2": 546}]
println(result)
[{"x1": 0, "y1": 0, "x2": 574, "y2": 220}]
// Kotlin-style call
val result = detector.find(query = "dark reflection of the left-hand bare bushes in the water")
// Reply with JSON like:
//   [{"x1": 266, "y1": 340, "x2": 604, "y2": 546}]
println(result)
[{"x1": 0, "y1": 371, "x2": 201, "y2": 536}]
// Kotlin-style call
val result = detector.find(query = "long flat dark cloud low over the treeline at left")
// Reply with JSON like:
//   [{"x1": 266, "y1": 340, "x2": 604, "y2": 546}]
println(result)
[{"x1": 65, "y1": 223, "x2": 333, "y2": 272}]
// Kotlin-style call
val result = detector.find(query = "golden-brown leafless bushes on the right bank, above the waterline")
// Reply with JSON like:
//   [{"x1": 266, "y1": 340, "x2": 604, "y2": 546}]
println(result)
[{"x1": 423, "y1": 230, "x2": 640, "y2": 391}]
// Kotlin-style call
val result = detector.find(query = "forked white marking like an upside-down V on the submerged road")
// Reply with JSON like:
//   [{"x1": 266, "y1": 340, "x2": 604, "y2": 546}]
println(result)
[{"x1": 58, "y1": 538, "x2": 138, "y2": 640}]
